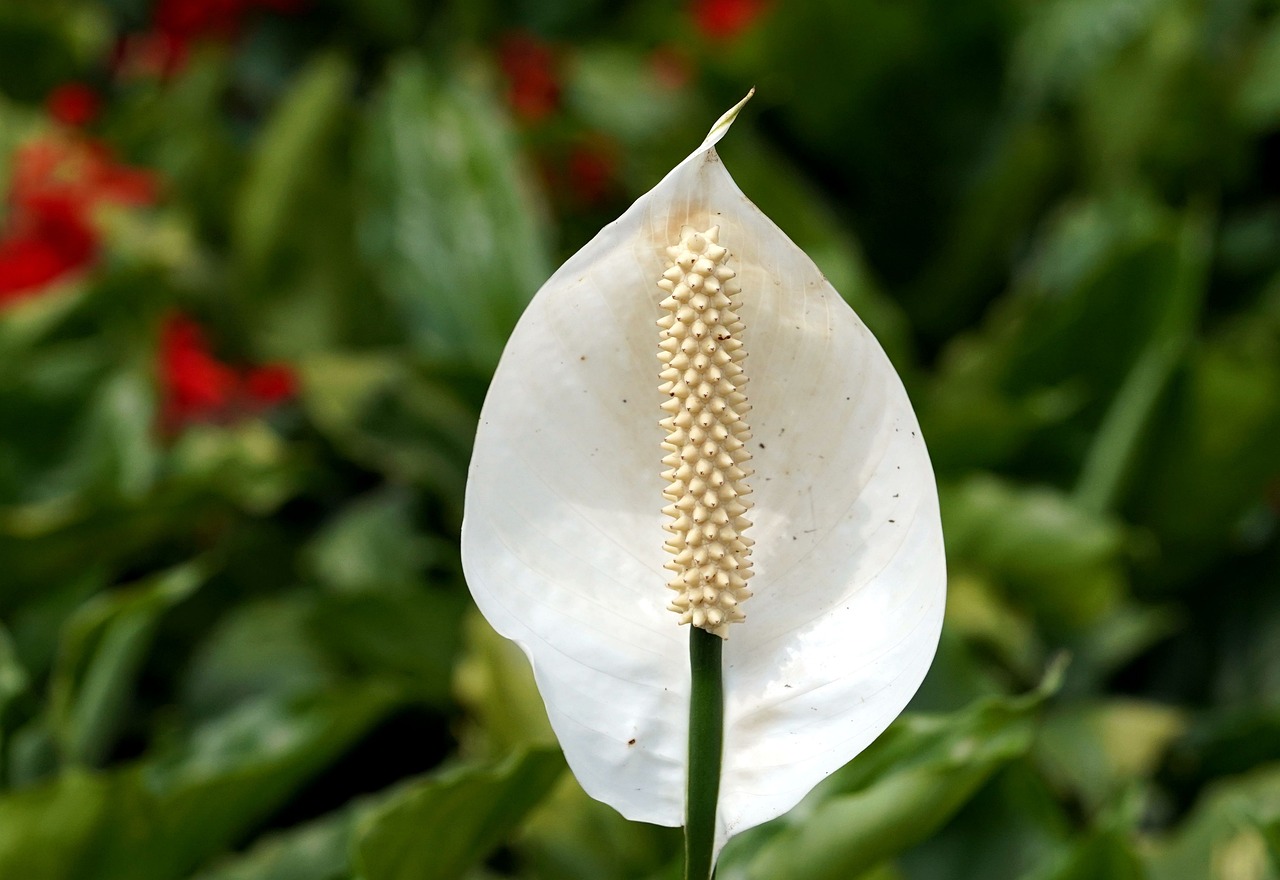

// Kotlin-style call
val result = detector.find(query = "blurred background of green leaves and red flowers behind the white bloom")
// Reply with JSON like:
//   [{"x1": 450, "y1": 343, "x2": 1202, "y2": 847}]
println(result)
[{"x1": 0, "y1": 0, "x2": 1280, "y2": 880}]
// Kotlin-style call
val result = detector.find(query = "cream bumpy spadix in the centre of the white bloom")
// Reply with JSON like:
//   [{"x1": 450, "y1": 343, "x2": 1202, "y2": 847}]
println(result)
[{"x1": 658, "y1": 226, "x2": 753, "y2": 638}]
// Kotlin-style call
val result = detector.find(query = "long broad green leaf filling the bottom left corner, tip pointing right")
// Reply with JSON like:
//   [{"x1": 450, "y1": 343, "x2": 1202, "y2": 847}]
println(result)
[{"x1": 0, "y1": 688, "x2": 396, "y2": 880}]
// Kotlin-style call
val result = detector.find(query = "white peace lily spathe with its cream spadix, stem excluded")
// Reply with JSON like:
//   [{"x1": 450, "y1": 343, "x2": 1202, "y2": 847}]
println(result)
[{"x1": 462, "y1": 95, "x2": 946, "y2": 869}]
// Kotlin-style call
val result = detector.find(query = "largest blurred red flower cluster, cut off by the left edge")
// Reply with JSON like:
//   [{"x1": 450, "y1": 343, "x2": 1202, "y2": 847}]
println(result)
[{"x1": 0, "y1": 138, "x2": 155, "y2": 302}]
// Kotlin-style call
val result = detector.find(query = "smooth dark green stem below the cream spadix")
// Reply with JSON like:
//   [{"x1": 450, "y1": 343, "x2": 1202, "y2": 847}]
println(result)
[{"x1": 685, "y1": 627, "x2": 724, "y2": 880}]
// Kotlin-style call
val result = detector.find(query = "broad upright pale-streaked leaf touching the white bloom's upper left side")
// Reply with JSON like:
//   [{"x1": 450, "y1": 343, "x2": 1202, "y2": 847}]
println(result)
[{"x1": 356, "y1": 56, "x2": 549, "y2": 370}]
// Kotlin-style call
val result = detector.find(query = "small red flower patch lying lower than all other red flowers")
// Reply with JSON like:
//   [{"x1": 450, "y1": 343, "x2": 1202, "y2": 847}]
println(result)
[{"x1": 160, "y1": 315, "x2": 298, "y2": 430}]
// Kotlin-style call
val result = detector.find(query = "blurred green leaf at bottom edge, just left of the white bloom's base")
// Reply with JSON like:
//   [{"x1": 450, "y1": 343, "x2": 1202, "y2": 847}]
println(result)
[{"x1": 355, "y1": 748, "x2": 564, "y2": 880}]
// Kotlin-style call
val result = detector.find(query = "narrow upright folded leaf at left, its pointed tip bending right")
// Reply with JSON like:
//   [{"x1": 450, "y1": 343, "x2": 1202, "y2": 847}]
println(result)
[{"x1": 49, "y1": 563, "x2": 206, "y2": 766}]
